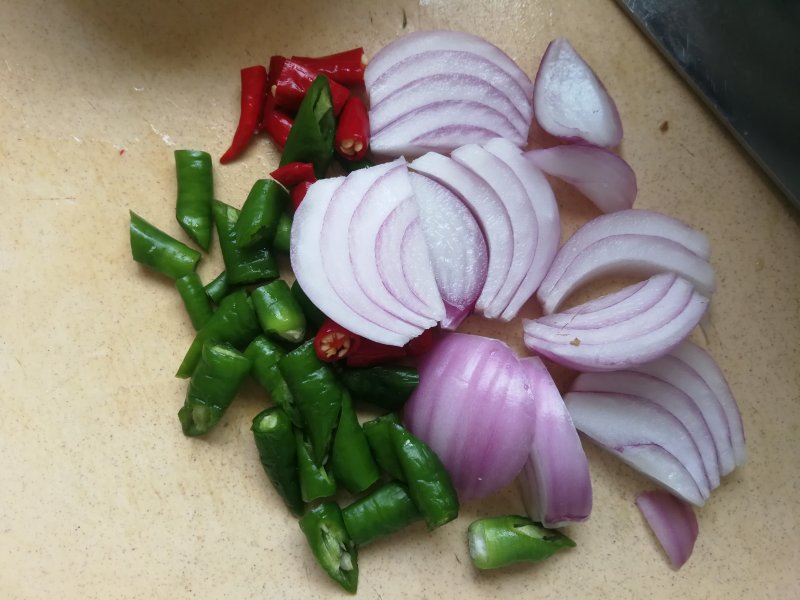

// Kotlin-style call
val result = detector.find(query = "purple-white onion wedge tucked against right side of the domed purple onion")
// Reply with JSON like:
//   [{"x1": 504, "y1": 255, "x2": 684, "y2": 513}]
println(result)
[{"x1": 519, "y1": 356, "x2": 592, "y2": 528}]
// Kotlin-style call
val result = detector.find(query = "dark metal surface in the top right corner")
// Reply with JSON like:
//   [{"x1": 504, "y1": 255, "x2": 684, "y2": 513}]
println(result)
[{"x1": 617, "y1": 0, "x2": 800, "y2": 208}]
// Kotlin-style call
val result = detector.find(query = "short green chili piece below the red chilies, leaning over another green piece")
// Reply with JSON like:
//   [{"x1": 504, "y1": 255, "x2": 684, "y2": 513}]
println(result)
[{"x1": 235, "y1": 179, "x2": 289, "y2": 248}]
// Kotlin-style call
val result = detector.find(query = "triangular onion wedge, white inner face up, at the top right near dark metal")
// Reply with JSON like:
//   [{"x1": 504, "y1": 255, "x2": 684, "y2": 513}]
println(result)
[{"x1": 533, "y1": 37, "x2": 622, "y2": 147}]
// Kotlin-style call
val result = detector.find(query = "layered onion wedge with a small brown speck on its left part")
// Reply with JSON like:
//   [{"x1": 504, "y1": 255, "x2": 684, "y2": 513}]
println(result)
[{"x1": 523, "y1": 274, "x2": 708, "y2": 371}]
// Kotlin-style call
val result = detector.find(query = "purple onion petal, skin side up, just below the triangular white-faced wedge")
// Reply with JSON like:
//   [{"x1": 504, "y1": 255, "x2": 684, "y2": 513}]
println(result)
[{"x1": 525, "y1": 145, "x2": 636, "y2": 213}]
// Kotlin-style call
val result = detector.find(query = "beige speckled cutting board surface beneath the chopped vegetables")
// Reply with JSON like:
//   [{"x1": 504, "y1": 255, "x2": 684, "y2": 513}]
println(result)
[{"x1": 0, "y1": 0, "x2": 800, "y2": 600}]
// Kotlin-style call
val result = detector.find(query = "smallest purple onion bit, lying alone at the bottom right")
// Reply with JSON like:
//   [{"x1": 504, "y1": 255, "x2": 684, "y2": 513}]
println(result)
[{"x1": 636, "y1": 490, "x2": 699, "y2": 569}]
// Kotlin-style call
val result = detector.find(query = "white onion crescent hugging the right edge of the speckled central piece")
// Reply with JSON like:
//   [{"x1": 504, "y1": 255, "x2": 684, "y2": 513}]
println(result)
[{"x1": 409, "y1": 152, "x2": 514, "y2": 311}]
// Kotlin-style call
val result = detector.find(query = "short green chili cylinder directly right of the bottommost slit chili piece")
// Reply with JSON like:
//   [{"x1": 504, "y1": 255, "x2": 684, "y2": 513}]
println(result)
[{"x1": 342, "y1": 482, "x2": 422, "y2": 546}]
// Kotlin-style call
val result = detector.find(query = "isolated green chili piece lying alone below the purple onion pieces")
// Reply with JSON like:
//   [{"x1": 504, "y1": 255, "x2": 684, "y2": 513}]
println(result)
[{"x1": 467, "y1": 515, "x2": 575, "y2": 569}]
